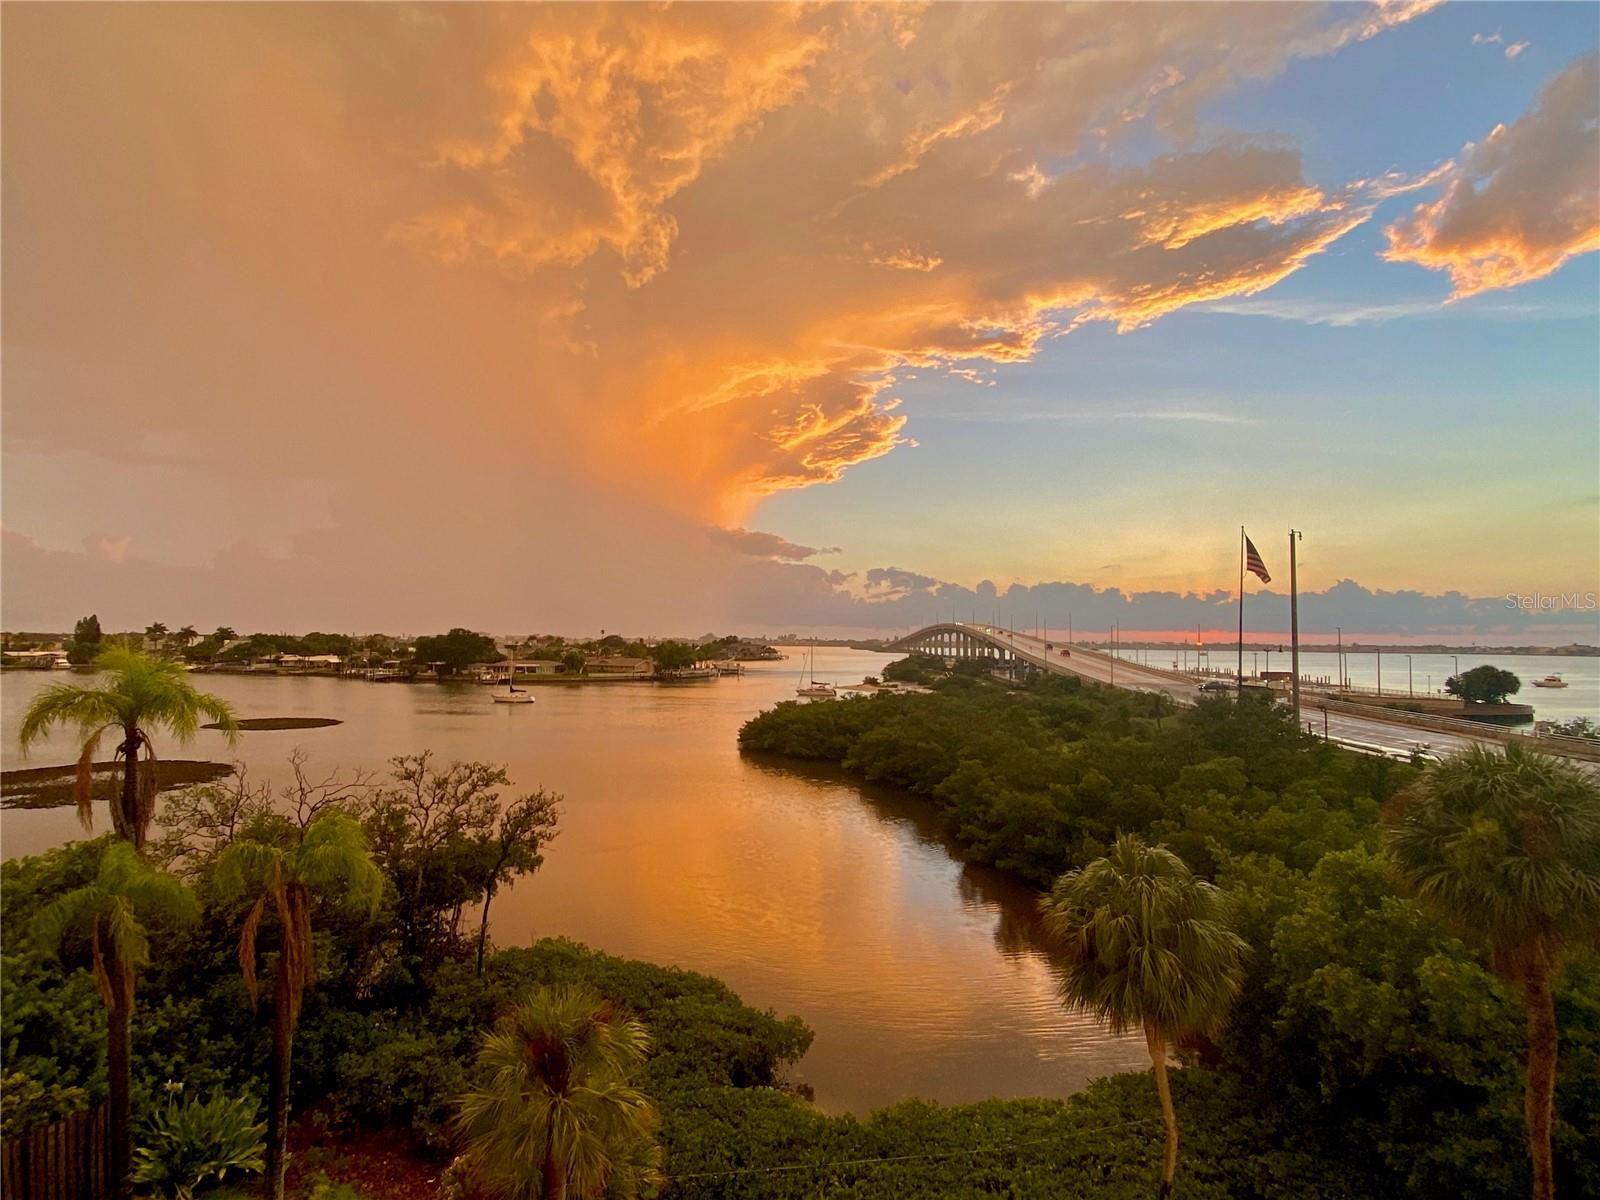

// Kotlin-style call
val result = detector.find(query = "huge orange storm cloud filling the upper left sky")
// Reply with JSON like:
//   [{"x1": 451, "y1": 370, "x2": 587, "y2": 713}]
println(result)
[{"x1": 3, "y1": 5, "x2": 1465, "y2": 624}]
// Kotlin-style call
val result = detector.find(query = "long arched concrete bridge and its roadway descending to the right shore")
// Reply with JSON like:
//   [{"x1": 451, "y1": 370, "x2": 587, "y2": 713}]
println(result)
[{"x1": 890, "y1": 621, "x2": 1548, "y2": 770}]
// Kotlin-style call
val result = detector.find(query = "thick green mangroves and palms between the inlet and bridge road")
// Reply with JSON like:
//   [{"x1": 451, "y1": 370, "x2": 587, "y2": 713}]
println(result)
[{"x1": 741, "y1": 662, "x2": 1600, "y2": 1197}]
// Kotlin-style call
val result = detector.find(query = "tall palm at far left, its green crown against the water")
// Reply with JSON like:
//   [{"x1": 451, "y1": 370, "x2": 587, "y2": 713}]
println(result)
[{"x1": 18, "y1": 646, "x2": 238, "y2": 853}]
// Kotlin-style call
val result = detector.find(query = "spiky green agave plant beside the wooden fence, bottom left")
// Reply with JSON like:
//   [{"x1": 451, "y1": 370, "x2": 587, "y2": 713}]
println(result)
[{"x1": 133, "y1": 1093, "x2": 267, "y2": 1200}]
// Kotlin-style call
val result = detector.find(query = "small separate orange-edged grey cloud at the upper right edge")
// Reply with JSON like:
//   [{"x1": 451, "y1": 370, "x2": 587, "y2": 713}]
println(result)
[{"x1": 1384, "y1": 54, "x2": 1600, "y2": 299}]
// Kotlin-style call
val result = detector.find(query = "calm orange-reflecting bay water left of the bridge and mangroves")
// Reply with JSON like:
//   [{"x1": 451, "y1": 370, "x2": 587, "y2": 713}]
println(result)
[{"x1": 0, "y1": 646, "x2": 1147, "y2": 1112}]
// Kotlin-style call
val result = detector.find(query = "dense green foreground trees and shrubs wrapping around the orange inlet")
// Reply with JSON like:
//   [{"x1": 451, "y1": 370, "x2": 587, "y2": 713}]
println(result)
[{"x1": 0, "y1": 661, "x2": 1600, "y2": 1200}]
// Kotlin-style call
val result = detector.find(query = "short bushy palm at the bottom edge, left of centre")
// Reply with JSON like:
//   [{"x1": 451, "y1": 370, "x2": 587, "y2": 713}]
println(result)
[{"x1": 456, "y1": 986, "x2": 662, "y2": 1200}]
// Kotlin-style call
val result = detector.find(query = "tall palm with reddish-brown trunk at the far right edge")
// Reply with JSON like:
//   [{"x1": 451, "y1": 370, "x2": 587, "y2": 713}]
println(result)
[{"x1": 1384, "y1": 744, "x2": 1600, "y2": 1200}]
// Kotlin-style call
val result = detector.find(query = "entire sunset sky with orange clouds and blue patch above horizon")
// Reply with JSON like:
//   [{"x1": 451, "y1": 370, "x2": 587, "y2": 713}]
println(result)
[{"x1": 9, "y1": 0, "x2": 1600, "y2": 642}]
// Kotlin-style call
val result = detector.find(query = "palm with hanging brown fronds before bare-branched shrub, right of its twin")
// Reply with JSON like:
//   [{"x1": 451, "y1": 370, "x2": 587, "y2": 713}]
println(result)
[{"x1": 213, "y1": 811, "x2": 384, "y2": 1200}]
